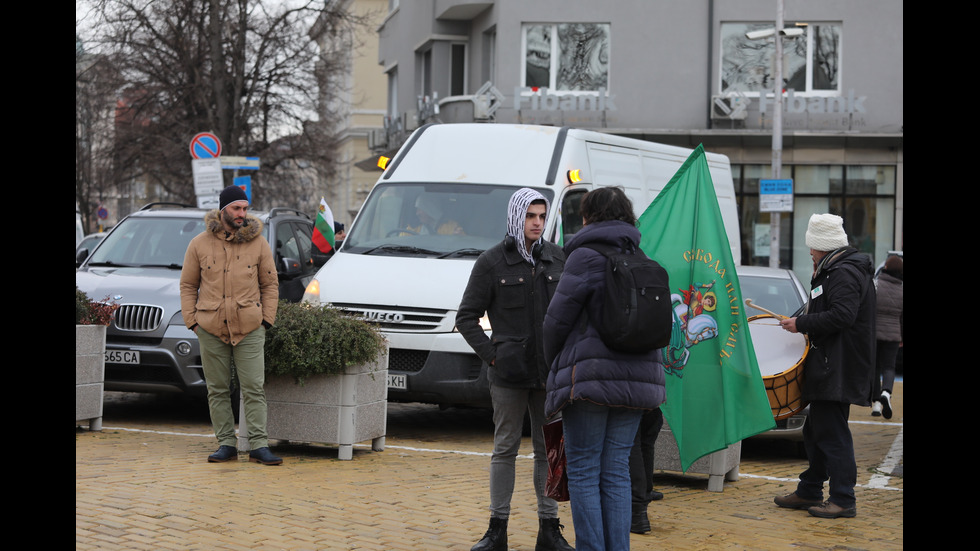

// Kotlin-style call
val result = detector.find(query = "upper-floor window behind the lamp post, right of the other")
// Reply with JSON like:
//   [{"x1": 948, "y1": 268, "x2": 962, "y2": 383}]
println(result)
[{"x1": 721, "y1": 22, "x2": 841, "y2": 95}]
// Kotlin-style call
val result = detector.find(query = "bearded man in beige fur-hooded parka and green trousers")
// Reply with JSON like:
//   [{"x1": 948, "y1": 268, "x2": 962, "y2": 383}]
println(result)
[{"x1": 180, "y1": 185, "x2": 282, "y2": 465}]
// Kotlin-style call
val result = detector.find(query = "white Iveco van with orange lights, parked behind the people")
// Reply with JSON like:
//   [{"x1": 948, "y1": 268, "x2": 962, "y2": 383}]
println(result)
[{"x1": 305, "y1": 124, "x2": 741, "y2": 407}]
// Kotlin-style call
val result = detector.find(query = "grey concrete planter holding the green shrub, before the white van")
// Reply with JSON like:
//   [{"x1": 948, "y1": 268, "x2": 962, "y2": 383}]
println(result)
[{"x1": 238, "y1": 348, "x2": 388, "y2": 460}]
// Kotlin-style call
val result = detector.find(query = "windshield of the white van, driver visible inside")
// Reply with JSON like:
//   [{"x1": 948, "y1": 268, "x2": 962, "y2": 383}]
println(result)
[{"x1": 341, "y1": 183, "x2": 554, "y2": 258}]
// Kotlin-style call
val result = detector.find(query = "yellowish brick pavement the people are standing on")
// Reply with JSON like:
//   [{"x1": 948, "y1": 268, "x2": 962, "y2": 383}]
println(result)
[{"x1": 75, "y1": 383, "x2": 904, "y2": 551}]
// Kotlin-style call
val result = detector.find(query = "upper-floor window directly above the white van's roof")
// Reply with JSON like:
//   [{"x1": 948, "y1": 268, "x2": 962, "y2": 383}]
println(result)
[{"x1": 522, "y1": 23, "x2": 609, "y2": 92}]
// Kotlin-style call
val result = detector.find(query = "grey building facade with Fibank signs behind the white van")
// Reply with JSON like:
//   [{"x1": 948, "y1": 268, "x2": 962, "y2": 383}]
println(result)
[{"x1": 370, "y1": 0, "x2": 904, "y2": 281}]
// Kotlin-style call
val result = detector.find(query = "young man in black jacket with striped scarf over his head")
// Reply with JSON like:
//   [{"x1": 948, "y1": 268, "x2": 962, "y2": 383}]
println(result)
[{"x1": 456, "y1": 188, "x2": 572, "y2": 551}]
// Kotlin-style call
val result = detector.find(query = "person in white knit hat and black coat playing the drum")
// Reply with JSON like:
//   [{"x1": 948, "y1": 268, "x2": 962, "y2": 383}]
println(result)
[{"x1": 774, "y1": 214, "x2": 875, "y2": 518}]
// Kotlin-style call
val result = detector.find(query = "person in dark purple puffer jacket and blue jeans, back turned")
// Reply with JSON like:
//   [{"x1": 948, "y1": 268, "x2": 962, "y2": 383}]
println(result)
[{"x1": 544, "y1": 187, "x2": 666, "y2": 551}]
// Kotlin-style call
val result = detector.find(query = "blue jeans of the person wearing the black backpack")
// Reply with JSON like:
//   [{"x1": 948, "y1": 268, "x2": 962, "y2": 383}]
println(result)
[{"x1": 562, "y1": 401, "x2": 643, "y2": 551}]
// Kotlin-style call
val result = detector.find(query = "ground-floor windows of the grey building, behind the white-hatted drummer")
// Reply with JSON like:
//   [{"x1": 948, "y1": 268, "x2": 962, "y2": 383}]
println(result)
[{"x1": 732, "y1": 165, "x2": 897, "y2": 282}]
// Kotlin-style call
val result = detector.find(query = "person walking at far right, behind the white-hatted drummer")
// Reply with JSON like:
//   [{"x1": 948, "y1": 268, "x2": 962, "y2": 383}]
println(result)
[{"x1": 871, "y1": 256, "x2": 905, "y2": 419}]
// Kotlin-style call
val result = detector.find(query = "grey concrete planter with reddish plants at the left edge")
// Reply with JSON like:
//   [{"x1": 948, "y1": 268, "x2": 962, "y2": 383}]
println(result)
[{"x1": 75, "y1": 325, "x2": 106, "y2": 430}]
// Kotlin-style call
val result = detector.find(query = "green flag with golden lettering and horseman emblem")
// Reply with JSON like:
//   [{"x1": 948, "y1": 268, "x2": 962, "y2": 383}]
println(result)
[{"x1": 637, "y1": 145, "x2": 775, "y2": 471}]
